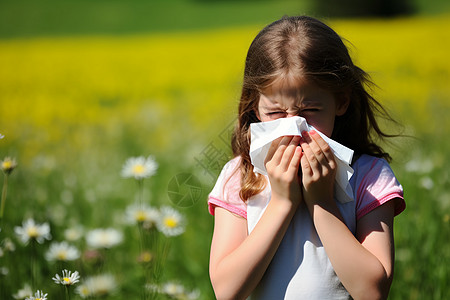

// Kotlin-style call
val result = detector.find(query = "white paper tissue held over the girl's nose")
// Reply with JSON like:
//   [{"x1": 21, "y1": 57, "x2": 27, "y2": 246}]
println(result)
[{"x1": 250, "y1": 116, "x2": 353, "y2": 203}]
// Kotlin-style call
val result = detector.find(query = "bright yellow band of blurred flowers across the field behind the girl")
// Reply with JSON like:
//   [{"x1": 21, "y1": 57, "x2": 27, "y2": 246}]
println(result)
[{"x1": 0, "y1": 16, "x2": 450, "y2": 162}]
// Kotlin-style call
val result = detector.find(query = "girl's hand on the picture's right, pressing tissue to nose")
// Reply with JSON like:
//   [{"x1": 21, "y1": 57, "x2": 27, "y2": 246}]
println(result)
[{"x1": 300, "y1": 130, "x2": 337, "y2": 205}]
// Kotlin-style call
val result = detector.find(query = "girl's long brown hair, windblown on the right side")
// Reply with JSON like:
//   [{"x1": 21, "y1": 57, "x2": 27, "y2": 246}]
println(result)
[{"x1": 231, "y1": 16, "x2": 398, "y2": 201}]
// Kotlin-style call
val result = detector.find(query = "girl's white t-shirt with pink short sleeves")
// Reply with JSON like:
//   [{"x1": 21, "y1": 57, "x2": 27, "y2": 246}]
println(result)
[{"x1": 208, "y1": 155, "x2": 405, "y2": 300}]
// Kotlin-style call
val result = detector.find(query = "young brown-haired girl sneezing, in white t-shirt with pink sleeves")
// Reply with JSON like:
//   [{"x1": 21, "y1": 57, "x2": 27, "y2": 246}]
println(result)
[{"x1": 208, "y1": 17, "x2": 405, "y2": 300}]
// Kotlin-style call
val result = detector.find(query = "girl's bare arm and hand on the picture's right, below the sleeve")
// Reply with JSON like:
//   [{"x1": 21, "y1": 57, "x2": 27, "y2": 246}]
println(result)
[{"x1": 301, "y1": 132, "x2": 394, "y2": 299}]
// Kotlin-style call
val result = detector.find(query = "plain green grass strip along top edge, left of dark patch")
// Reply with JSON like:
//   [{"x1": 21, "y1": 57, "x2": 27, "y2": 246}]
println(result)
[{"x1": 0, "y1": 0, "x2": 308, "y2": 38}]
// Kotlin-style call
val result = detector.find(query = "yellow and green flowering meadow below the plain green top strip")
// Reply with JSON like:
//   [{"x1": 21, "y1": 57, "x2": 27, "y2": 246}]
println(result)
[{"x1": 0, "y1": 5, "x2": 450, "y2": 300}]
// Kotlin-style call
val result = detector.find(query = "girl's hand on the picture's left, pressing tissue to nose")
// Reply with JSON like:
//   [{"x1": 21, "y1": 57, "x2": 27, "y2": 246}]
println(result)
[{"x1": 264, "y1": 136, "x2": 302, "y2": 206}]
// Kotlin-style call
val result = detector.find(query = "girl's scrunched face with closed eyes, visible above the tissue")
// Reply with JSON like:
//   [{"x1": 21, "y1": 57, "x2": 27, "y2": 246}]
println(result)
[{"x1": 256, "y1": 78, "x2": 348, "y2": 137}]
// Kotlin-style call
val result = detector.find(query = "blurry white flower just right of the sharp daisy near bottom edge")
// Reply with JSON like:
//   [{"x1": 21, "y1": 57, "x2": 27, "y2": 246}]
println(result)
[{"x1": 76, "y1": 274, "x2": 117, "y2": 298}]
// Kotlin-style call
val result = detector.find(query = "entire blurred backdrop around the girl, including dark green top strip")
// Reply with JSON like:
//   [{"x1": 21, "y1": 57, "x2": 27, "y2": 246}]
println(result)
[{"x1": 0, "y1": 0, "x2": 450, "y2": 299}]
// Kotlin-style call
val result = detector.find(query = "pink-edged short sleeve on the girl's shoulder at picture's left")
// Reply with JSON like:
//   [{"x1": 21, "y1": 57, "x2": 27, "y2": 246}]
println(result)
[{"x1": 208, "y1": 156, "x2": 247, "y2": 218}]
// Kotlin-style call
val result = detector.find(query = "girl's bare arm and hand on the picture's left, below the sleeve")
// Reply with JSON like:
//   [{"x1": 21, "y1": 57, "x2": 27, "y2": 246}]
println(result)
[{"x1": 209, "y1": 137, "x2": 301, "y2": 299}]
